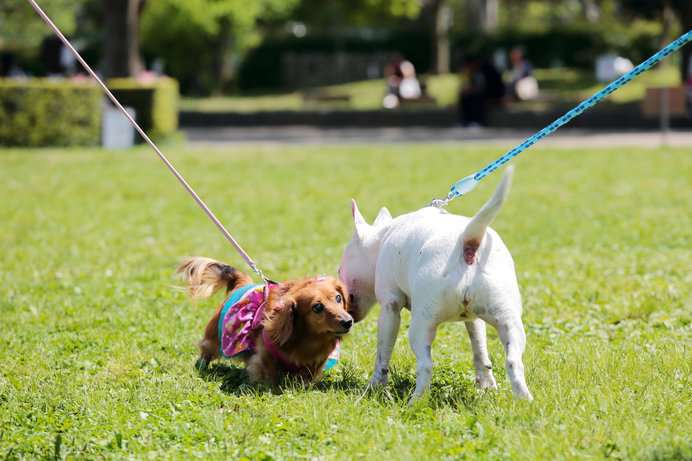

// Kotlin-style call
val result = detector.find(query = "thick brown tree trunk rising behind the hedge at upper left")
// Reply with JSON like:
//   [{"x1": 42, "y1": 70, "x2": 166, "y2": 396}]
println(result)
[{"x1": 101, "y1": 0, "x2": 144, "y2": 78}]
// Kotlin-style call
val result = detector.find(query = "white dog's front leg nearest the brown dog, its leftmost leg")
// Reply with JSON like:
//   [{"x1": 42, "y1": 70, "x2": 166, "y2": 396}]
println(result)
[{"x1": 368, "y1": 300, "x2": 403, "y2": 388}]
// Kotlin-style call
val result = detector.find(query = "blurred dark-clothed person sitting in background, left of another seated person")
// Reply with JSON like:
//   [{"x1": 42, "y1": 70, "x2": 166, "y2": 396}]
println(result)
[{"x1": 458, "y1": 56, "x2": 505, "y2": 127}]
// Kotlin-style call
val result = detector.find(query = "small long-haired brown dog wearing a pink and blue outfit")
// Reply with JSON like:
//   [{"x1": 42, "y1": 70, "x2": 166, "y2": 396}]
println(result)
[{"x1": 176, "y1": 257, "x2": 353, "y2": 386}]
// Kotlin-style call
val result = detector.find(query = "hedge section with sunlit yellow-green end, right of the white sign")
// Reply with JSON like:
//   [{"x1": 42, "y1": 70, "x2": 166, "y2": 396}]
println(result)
[{"x1": 106, "y1": 77, "x2": 179, "y2": 142}]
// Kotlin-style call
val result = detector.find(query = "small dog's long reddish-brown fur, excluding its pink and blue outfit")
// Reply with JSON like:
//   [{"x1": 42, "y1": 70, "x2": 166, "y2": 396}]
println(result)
[{"x1": 176, "y1": 257, "x2": 353, "y2": 386}]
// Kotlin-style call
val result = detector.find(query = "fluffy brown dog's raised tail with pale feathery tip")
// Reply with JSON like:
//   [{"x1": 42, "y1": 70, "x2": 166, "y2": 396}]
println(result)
[{"x1": 175, "y1": 256, "x2": 252, "y2": 299}]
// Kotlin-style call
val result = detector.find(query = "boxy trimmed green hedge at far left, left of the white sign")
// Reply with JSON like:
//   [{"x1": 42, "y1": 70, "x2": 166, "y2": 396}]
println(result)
[{"x1": 0, "y1": 79, "x2": 102, "y2": 147}]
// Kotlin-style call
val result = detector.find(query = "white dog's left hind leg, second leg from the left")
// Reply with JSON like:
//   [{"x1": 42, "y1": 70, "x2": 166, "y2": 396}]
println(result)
[{"x1": 408, "y1": 309, "x2": 437, "y2": 405}]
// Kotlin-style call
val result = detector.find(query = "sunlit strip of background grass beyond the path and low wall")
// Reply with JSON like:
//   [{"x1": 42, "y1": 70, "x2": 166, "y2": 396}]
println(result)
[{"x1": 180, "y1": 66, "x2": 680, "y2": 112}]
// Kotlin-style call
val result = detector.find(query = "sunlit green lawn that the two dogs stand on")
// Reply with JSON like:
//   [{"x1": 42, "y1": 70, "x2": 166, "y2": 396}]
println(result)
[{"x1": 0, "y1": 145, "x2": 692, "y2": 460}]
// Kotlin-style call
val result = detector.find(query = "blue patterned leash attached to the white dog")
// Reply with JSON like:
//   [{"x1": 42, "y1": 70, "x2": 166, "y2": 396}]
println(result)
[{"x1": 430, "y1": 30, "x2": 692, "y2": 208}]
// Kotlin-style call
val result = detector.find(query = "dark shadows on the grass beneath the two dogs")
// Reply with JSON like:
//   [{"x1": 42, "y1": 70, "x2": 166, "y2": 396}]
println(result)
[{"x1": 199, "y1": 362, "x2": 480, "y2": 409}]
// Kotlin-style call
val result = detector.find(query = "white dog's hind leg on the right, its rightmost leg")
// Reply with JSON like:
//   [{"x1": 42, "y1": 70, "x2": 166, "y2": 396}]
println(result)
[{"x1": 493, "y1": 316, "x2": 533, "y2": 401}]
